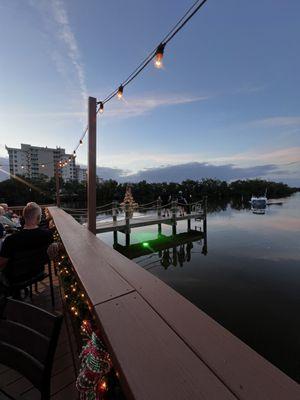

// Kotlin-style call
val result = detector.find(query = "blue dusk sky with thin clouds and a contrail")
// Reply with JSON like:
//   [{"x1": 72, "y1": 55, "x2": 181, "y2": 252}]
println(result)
[{"x1": 0, "y1": 0, "x2": 300, "y2": 186}]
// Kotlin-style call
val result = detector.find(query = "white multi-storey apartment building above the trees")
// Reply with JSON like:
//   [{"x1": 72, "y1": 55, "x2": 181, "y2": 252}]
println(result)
[{"x1": 6, "y1": 144, "x2": 77, "y2": 181}]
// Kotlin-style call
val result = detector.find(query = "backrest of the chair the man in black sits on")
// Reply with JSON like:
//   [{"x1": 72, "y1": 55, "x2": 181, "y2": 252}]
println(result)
[{"x1": 4, "y1": 246, "x2": 49, "y2": 284}]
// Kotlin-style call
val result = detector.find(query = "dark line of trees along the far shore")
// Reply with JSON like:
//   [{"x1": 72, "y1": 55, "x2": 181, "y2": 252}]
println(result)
[{"x1": 0, "y1": 177, "x2": 299, "y2": 208}]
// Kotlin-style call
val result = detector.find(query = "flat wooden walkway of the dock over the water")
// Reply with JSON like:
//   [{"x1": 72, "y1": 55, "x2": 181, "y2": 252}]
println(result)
[{"x1": 96, "y1": 212, "x2": 204, "y2": 233}]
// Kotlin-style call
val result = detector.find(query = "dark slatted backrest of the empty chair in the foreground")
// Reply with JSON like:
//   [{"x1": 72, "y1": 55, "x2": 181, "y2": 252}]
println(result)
[{"x1": 0, "y1": 299, "x2": 63, "y2": 398}]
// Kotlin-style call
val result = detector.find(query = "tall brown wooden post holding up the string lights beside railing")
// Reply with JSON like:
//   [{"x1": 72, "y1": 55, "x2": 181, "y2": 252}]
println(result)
[{"x1": 87, "y1": 97, "x2": 97, "y2": 235}]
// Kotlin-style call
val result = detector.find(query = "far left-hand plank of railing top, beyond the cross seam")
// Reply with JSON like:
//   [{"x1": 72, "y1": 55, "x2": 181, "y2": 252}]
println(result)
[{"x1": 49, "y1": 207, "x2": 133, "y2": 305}]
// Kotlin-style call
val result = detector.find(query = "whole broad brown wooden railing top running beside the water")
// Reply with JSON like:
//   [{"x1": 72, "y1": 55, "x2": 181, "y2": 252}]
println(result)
[{"x1": 49, "y1": 207, "x2": 300, "y2": 400}]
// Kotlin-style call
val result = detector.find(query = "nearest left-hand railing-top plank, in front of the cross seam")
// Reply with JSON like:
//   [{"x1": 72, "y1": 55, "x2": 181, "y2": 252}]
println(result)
[{"x1": 95, "y1": 293, "x2": 236, "y2": 400}]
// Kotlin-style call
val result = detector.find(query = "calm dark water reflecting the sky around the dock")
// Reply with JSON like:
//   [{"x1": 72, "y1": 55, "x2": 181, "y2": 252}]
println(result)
[{"x1": 100, "y1": 193, "x2": 300, "y2": 383}]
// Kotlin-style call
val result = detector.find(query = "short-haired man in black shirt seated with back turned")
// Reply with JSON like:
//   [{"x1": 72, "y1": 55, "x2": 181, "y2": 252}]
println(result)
[{"x1": 0, "y1": 203, "x2": 53, "y2": 284}]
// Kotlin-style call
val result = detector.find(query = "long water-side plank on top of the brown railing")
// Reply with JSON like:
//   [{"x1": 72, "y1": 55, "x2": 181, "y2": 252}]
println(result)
[{"x1": 95, "y1": 239, "x2": 300, "y2": 400}]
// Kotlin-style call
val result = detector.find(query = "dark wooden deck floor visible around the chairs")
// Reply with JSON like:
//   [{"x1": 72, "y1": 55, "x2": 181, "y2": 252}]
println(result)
[{"x1": 0, "y1": 277, "x2": 78, "y2": 400}]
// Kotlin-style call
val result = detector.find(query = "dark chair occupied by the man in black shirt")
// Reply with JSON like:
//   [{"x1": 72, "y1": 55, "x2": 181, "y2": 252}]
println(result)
[{"x1": 4, "y1": 247, "x2": 55, "y2": 306}]
